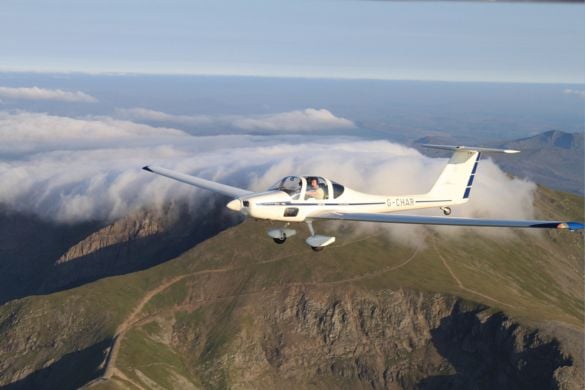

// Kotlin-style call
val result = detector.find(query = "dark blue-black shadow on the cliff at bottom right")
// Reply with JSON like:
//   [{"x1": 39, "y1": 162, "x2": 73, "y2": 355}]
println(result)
[{"x1": 419, "y1": 306, "x2": 573, "y2": 389}]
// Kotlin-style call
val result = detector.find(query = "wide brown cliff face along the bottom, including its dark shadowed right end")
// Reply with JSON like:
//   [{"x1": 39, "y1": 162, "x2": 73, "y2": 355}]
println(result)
[{"x1": 170, "y1": 287, "x2": 583, "y2": 389}]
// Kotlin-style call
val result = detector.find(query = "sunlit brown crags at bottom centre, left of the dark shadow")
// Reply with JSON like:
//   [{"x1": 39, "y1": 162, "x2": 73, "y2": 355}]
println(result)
[{"x1": 256, "y1": 291, "x2": 453, "y2": 388}]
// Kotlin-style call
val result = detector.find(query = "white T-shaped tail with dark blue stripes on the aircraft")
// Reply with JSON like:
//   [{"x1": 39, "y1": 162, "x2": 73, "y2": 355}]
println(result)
[{"x1": 423, "y1": 145, "x2": 518, "y2": 204}]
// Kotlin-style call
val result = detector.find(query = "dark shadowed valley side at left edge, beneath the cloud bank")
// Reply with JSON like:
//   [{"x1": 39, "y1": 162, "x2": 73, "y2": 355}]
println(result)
[{"x1": 0, "y1": 202, "x2": 240, "y2": 305}]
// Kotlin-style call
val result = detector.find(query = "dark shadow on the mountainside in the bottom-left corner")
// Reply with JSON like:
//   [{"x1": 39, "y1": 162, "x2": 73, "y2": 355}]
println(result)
[{"x1": 0, "y1": 339, "x2": 112, "y2": 390}]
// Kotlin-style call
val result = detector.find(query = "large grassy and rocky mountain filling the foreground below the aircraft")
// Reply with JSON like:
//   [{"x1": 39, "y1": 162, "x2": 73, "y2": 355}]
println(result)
[{"x1": 0, "y1": 188, "x2": 585, "y2": 389}]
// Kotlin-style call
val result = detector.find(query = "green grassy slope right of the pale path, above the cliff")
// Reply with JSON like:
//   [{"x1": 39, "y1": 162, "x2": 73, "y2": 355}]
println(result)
[{"x1": 99, "y1": 190, "x2": 583, "y2": 385}]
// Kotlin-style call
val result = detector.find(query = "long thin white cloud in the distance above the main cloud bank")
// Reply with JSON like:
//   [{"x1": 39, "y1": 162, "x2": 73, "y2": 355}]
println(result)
[{"x1": 116, "y1": 107, "x2": 355, "y2": 132}]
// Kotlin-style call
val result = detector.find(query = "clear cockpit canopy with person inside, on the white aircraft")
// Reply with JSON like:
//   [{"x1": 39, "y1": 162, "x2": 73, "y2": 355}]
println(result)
[{"x1": 268, "y1": 176, "x2": 345, "y2": 200}]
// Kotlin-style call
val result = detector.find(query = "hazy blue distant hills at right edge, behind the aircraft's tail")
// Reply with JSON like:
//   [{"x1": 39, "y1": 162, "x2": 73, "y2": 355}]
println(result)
[{"x1": 414, "y1": 130, "x2": 585, "y2": 195}]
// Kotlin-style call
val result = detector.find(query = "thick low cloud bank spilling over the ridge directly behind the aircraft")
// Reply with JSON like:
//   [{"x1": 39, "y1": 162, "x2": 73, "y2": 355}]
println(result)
[{"x1": 0, "y1": 112, "x2": 535, "y2": 244}]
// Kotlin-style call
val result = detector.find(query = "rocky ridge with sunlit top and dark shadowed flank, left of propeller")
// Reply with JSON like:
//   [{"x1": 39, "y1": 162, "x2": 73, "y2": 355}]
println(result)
[{"x1": 38, "y1": 203, "x2": 237, "y2": 293}]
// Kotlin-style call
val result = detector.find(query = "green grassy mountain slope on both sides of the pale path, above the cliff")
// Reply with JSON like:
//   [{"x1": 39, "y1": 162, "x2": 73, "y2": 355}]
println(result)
[{"x1": 0, "y1": 189, "x2": 584, "y2": 388}]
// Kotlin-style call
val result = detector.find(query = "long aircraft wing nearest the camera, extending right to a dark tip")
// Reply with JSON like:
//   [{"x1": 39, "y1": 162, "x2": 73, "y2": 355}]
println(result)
[{"x1": 310, "y1": 212, "x2": 585, "y2": 230}]
